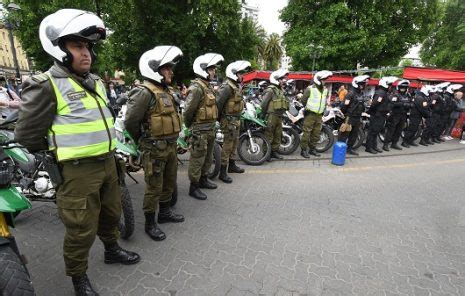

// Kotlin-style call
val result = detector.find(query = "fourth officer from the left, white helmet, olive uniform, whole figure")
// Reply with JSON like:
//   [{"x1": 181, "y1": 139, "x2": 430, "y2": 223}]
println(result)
[{"x1": 217, "y1": 61, "x2": 251, "y2": 183}]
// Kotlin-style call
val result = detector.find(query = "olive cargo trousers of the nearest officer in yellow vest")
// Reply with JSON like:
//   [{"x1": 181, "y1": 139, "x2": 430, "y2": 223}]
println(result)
[{"x1": 57, "y1": 156, "x2": 121, "y2": 276}]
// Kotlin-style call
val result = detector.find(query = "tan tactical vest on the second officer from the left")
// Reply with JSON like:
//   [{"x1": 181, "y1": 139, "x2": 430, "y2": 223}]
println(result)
[{"x1": 143, "y1": 81, "x2": 181, "y2": 139}]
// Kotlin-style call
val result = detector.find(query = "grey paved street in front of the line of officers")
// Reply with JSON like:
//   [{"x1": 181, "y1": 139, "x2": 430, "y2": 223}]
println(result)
[{"x1": 10, "y1": 141, "x2": 465, "y2": 296}]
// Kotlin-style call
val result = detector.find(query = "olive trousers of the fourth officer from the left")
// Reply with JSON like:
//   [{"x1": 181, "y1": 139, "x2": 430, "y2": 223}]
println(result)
[{"x1": 221, "y1": 118, "x2": 241, "y2": 165}]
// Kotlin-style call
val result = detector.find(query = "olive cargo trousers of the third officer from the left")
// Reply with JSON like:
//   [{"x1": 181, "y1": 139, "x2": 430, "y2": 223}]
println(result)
[{"x1": 188, "y1": 129, "x2": 216, "y2": 183}]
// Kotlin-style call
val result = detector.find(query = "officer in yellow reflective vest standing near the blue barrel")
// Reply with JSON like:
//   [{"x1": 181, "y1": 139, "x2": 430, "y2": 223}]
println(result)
[{"x1": 300, "y1": 70, "x2": 333, "y2": 158}]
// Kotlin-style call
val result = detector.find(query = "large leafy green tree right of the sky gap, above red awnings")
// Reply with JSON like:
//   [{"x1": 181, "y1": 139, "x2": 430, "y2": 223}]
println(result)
[{"x1": 281, "y1": 0, "x2": 438, "y2": 70}]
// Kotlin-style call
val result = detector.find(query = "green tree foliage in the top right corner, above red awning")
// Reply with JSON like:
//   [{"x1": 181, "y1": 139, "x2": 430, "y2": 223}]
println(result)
[{"x1": 420, "y1": 0, "x2": 465, "y2": 70}]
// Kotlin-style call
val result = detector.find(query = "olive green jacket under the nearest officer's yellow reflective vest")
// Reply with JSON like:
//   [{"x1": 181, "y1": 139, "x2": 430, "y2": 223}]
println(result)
[{"x1": 15, "y1": 63, "x2": 104, "y2": 152}]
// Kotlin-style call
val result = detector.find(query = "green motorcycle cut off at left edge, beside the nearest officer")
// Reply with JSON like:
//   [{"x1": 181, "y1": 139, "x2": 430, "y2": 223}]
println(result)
[{"x1": 0, "y1": 144, "x2": 35, "y2": 296}]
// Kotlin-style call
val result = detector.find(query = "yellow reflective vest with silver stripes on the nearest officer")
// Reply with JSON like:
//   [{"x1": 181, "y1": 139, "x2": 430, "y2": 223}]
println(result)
[{"x1": 47, "y1": 73, "x2": 116, "y2": 161}]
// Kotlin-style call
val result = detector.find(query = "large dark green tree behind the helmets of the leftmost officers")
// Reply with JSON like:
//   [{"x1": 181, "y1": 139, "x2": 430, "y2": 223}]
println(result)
[{"x1": 7, "y1": 0, "x2": 260, "y2": 80}]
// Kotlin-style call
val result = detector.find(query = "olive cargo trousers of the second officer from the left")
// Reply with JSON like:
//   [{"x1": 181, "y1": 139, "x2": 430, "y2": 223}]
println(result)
[{"x1": 142, "y1": 141, "x2": 178, "y2": 213}]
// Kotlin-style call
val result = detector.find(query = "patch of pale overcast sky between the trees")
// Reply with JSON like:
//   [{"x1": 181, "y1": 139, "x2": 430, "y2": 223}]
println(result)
[{"x1": 247, "y1": 0, "x2": 288, "y2": 35}]
